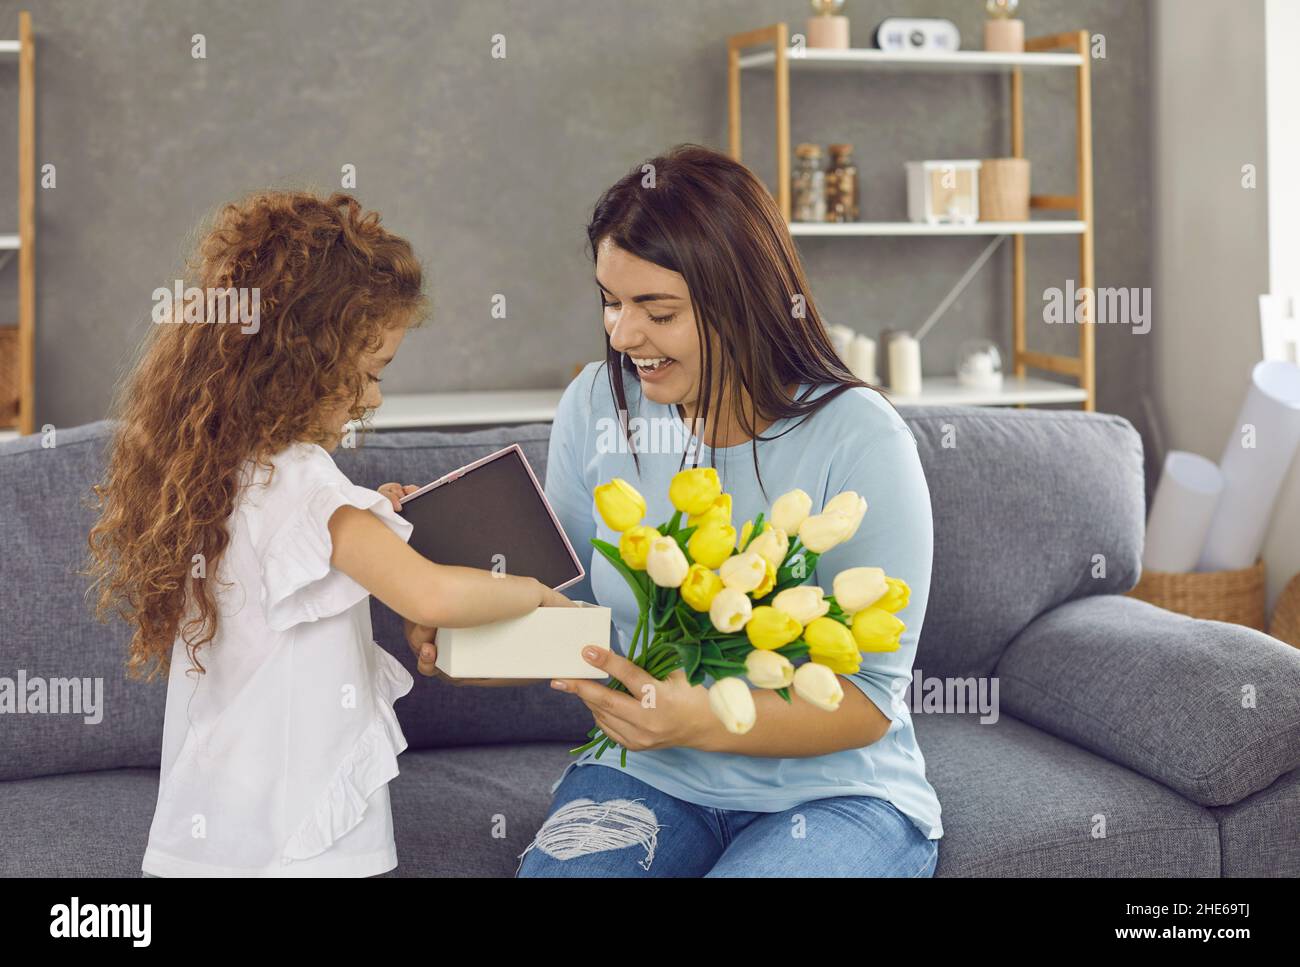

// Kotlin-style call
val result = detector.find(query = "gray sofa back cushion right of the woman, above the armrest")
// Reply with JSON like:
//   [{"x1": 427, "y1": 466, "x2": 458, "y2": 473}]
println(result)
[{"x1": 899, "y1": 407, "x2": 1145, "y2": 677}]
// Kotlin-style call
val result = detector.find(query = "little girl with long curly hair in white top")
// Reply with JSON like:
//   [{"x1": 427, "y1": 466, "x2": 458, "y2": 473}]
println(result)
[{"x1": 90, "y1": 191, "x2": 569, "y2": 876}]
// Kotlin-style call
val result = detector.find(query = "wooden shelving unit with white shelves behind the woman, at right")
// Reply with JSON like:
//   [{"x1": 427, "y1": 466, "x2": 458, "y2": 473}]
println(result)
[{"x1": 727, "y1": 23, "x2": 1096, "y2": 411}]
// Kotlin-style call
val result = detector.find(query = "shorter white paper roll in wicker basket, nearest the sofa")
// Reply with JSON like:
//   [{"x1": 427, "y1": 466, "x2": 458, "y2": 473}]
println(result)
[{"x1": 1141, "y1": 450, "x2": 1223, "y2": 574}]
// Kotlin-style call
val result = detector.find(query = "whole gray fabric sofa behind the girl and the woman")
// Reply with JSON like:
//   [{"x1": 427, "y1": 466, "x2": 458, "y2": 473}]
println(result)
[{"x1": 0, "y1": 407, "x2": 1300, "y2": 876}]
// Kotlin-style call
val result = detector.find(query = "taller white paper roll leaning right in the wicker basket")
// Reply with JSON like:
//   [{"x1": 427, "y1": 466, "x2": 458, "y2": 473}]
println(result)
[{"x1": 1199, "y1": 360, "x2": 1300, "y2": 571}]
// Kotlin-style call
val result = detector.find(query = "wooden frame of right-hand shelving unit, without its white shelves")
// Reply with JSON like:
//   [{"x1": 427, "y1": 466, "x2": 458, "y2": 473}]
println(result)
[{"x1": 727, "y1": 23, "x2": 1096, "y2": 411}]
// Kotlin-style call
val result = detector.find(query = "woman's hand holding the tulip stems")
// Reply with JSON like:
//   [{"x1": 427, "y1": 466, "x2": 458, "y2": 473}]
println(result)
[{"x1": 551, "y1": 645, "x2": 720, "y2": 753}]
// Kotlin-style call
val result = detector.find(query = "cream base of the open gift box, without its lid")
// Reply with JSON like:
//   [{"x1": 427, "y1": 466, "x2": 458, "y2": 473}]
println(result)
[{"x1": 437, "y1": 600, "x2": 610, "y2": 678}]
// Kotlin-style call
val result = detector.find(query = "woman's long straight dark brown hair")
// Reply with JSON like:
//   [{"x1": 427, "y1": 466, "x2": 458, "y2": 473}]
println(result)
[{"x1": 586, "y1": 144, "x2": 894, "y2": 496}]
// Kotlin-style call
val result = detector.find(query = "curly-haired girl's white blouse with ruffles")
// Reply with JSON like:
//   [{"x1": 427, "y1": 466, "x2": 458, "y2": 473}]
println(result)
[{"x1": 142, "y1": 443, "x2": 413, "y2": 876}]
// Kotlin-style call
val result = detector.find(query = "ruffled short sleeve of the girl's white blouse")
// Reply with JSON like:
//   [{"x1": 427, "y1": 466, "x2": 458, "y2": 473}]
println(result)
[{"x1": 260, "y1": 450, "x2": 412, "y2": 632}]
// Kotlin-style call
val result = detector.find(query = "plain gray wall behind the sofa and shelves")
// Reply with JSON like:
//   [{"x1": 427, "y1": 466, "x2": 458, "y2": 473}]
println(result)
[{"x1": 0, "y1": 0, "x2": 1151, "y2": 462}]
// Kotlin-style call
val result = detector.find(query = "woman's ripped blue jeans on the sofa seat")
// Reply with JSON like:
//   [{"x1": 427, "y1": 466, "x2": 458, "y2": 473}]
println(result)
[{"x1": 516, "y1": 766, "x2": 939, "y2": 877}]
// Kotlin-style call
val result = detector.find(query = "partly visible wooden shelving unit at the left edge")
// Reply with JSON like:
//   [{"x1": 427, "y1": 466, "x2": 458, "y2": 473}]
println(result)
[{"x1": 0, "y1": 10, "x2": 36, "y2": 439}]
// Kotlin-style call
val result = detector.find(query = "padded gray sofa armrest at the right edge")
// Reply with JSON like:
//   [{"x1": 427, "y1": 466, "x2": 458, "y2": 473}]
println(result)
[{"x1": 996, "y1": 594, "x2": 1300, "y2": 806}]
